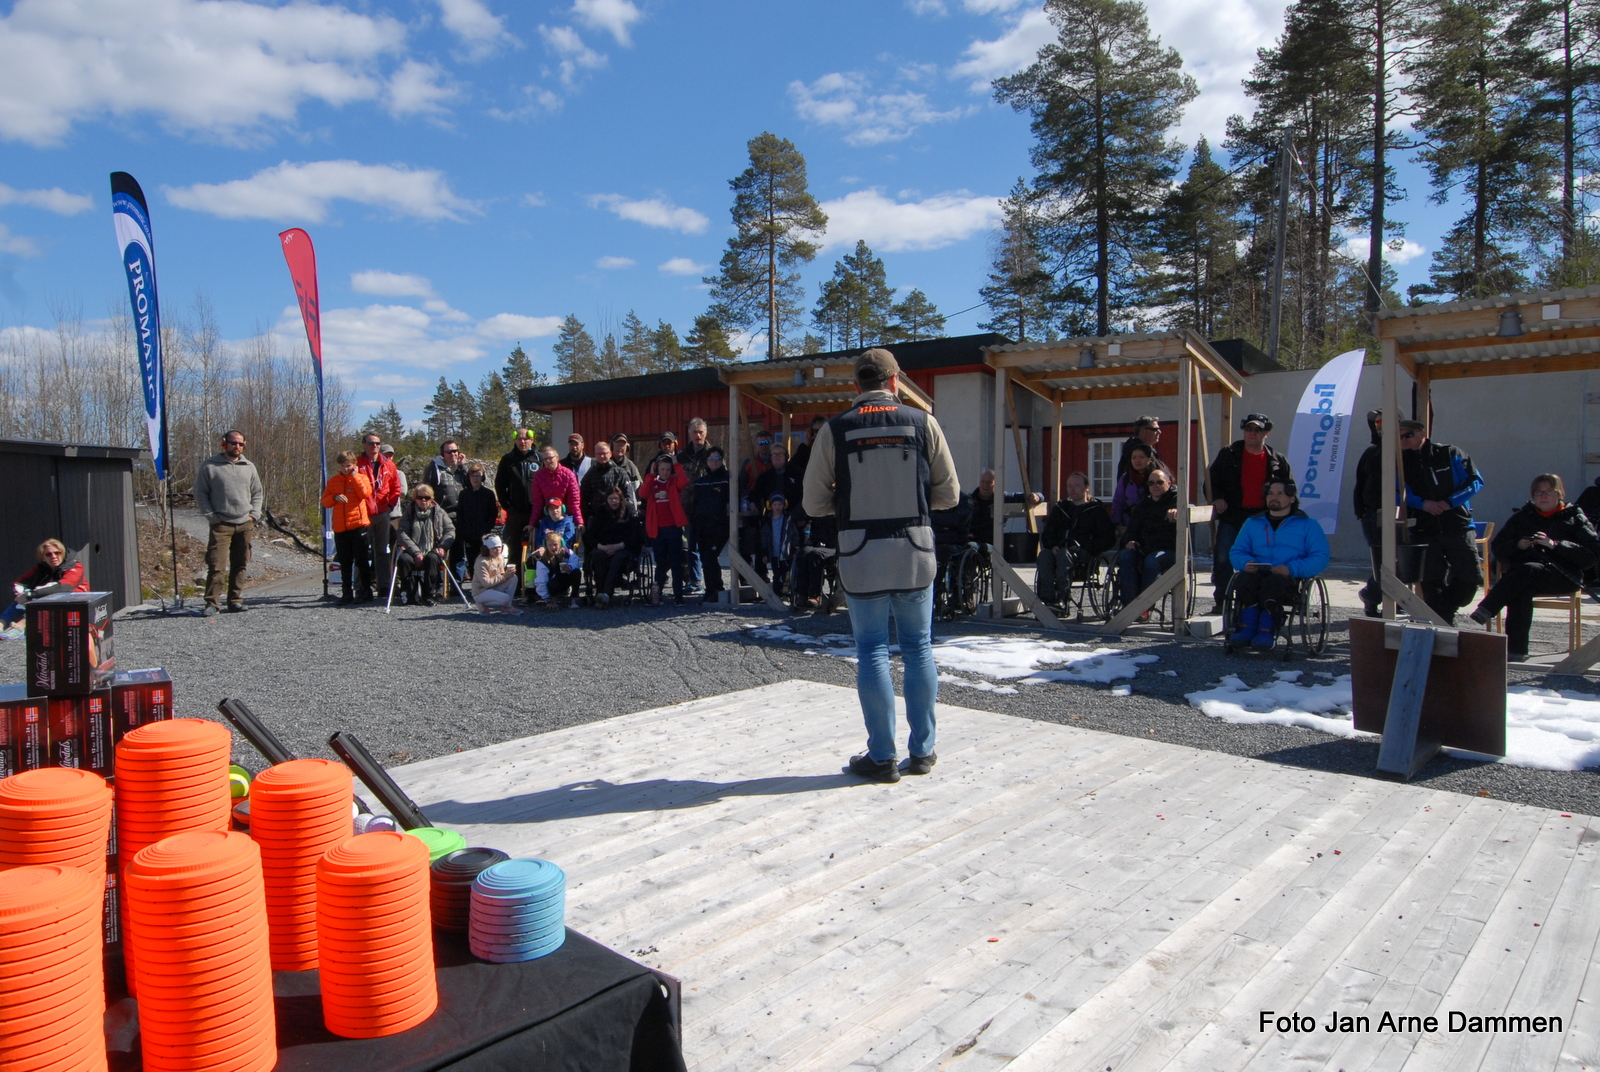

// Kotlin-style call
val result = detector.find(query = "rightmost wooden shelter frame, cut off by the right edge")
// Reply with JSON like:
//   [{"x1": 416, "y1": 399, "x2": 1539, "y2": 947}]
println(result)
[{"x1": 1376, "y1": 286, "x2": 1600, "y2": 674}]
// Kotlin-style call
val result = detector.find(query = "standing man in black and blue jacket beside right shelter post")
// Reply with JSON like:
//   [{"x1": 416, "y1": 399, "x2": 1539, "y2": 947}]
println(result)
[{"x1": 1400, "y1": 421, "x2": 1483, "y2": 624}]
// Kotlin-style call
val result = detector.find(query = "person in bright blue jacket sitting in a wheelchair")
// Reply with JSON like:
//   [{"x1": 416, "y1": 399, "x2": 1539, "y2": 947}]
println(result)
[{"x1": 1227, "y1": 480, "x2": 1330, "y2": 648}]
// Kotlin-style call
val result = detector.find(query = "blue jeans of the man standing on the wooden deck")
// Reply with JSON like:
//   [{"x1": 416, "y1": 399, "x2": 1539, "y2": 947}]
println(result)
[{"x1": 845, "y1": 584, "x2": 939, "y2": 762}]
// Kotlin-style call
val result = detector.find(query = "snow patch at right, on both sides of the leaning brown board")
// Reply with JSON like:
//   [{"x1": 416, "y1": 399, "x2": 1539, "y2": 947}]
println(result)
[{"x1": 1189, "y1": 670, "x2": 1600, "y2": 771}]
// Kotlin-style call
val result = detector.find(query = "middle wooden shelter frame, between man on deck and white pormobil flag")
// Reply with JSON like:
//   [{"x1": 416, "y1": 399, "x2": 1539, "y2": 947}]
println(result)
[{"x1": 984, "y1": 331, "x2": 1245, "y2": 637}]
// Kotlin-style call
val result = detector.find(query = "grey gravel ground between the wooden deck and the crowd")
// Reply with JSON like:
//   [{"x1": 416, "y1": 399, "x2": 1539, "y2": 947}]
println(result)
[{"x1": 0, "y1": 576, "x2": 1600, "y2": 814}]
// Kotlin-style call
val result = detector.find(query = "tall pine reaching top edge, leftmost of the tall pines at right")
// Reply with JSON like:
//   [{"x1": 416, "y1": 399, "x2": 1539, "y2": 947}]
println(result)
[{"x1": 995, "y1": 0, "x2": 1198, "y2": 334}]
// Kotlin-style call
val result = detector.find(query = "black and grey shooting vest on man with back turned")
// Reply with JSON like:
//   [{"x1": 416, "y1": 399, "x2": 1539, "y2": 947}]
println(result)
[{"x1": 827, "y1": 392, "x2": 938, "y2": 595}]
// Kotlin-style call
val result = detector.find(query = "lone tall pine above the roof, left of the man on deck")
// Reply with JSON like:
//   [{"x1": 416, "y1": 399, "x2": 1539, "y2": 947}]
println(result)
[{"x1": 706, "y1": 131, "x2": 827, "y2": 360}]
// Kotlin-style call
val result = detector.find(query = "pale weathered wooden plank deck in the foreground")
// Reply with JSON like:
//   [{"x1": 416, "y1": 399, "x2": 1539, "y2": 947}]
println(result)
[{"x1": 394, "y1": 682, "x2": 1600, "y2": 1072}]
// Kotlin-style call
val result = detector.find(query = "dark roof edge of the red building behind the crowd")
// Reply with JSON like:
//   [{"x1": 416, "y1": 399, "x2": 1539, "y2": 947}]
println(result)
[{"x1": 517, "y1": 331, "x2": 1011, "y2": 413}]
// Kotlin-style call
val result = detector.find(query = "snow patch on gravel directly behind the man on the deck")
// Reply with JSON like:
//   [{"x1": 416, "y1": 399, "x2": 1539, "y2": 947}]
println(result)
[{"x1": 749, "y1": 626, "x2": 1158, "y2": 694}]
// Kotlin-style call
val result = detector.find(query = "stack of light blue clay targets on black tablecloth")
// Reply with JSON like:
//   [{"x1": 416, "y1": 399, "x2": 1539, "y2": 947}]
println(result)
[{"x1": 467, "y1": 859, "x2": 566, "y2": 963}]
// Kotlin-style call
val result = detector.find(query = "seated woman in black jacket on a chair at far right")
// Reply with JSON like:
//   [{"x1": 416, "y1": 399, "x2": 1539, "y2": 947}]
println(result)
[{"x1": 1470, "y1": 472, "x2": 1600, "y2": 662}]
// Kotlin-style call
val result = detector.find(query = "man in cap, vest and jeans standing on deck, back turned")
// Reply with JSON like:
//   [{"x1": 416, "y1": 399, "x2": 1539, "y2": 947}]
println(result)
[{"x1": 805, "y1": 349, "x2": 960, "y2": 782}]
